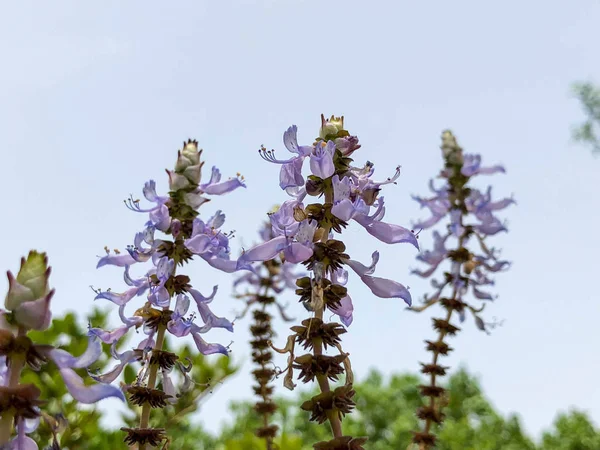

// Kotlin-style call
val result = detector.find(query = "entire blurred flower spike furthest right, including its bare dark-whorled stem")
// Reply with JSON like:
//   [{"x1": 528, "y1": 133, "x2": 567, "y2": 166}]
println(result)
[{"x1": 412, "y1": 131, "x2": 514, "y2": 449}]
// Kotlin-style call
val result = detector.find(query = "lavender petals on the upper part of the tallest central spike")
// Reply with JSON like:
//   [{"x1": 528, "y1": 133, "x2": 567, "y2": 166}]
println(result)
[{"x1": 246, "y1": 121, "x2": 419, "y2": 312}]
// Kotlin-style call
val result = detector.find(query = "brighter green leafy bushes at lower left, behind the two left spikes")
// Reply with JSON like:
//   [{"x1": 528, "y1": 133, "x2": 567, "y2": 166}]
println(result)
[{"x1": 22, "y1": 309, "x2": 237, "y2": 450}]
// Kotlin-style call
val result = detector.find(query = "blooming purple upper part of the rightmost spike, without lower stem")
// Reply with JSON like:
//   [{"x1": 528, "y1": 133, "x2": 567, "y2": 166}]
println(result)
[{"x1": 412, "y1": 133, "x2": 515, "y2": 330}]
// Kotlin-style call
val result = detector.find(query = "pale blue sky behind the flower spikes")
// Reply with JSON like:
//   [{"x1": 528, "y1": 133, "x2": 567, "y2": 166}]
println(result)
[{"x1": 0, "y1": 1, "x2": 600, "y2": 440}]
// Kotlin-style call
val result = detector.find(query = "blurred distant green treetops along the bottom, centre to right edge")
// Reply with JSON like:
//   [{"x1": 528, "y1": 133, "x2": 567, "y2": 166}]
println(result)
[{"x1": 215, "y1": 370, "x2": 600, "y2": 450}]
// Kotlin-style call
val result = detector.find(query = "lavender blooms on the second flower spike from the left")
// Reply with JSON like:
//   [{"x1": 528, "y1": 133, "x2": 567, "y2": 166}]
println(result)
[{"x1": 90, "y1": 152, "x2": 239, "y2": 362}]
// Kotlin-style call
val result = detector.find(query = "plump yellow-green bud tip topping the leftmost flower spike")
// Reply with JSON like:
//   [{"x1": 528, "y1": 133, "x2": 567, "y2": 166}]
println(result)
[{"x1": 4, "y1": 250, "x2": 51, "y2": 311}]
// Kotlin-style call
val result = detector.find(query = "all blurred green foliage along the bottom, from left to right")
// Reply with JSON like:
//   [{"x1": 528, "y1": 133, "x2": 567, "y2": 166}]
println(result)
[{"x1": 24, "y1": 309, "x2": 600, "y2": 450}]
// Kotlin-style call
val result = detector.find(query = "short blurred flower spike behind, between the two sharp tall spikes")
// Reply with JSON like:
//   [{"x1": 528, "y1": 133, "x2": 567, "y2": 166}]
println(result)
[{"x1": 234, "y1": 223, "x2": 299, "y2": 444}]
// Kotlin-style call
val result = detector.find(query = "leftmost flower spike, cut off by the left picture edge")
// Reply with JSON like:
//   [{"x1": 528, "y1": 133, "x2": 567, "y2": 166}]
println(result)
[{"x1": 0, "y1": 251, "x2": 124, "y2": 450}]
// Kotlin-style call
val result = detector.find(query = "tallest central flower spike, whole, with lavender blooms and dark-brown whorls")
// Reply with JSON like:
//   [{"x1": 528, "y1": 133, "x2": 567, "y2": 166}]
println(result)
[{"x1": 243, "y1": 116, "x2": 418, "y2": 450}]
